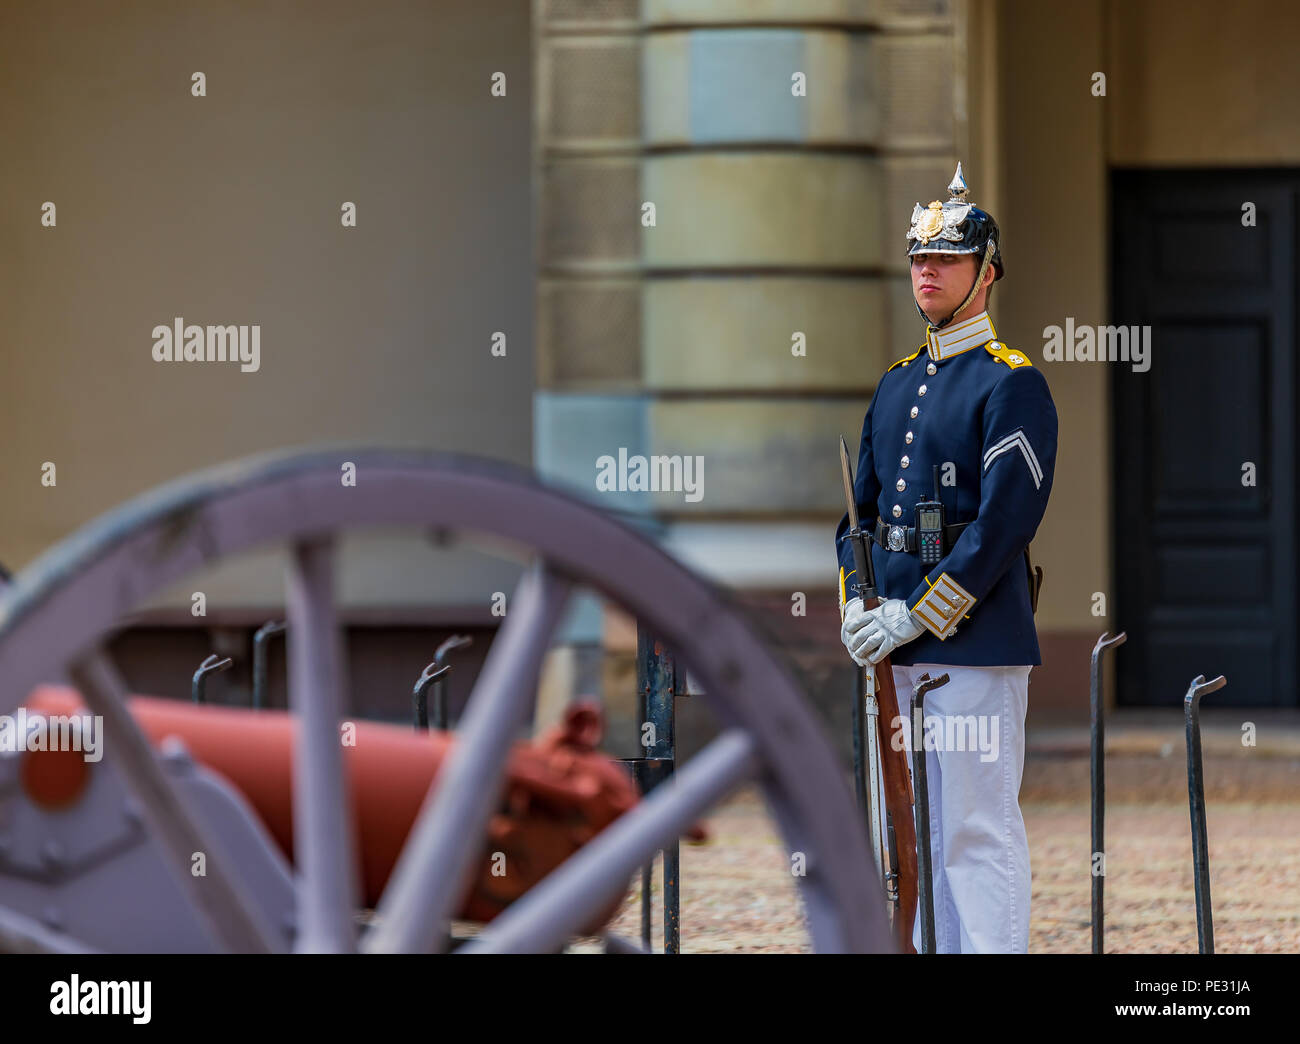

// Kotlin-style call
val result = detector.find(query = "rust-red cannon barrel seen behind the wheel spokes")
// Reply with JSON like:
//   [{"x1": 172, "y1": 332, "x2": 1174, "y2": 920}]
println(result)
[{"x1": 15, "y1": 685, "x2": 638, "y2": 932}]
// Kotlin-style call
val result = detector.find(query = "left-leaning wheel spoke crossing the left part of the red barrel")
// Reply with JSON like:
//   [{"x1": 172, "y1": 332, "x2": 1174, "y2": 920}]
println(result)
[{"x1": 69, "y1": 653, "x2": 278, "y2": 953}]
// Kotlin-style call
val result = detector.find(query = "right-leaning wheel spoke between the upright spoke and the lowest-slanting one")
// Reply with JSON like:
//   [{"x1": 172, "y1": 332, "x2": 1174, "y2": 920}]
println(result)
[{"x1": 364, "y1": 566, "x2": 569, "y2": 953}]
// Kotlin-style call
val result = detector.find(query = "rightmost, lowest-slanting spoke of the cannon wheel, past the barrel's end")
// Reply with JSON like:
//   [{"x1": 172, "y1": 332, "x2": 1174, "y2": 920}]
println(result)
[{"x1": 456, "y1": 728, "x2": 759, "y2": 953}]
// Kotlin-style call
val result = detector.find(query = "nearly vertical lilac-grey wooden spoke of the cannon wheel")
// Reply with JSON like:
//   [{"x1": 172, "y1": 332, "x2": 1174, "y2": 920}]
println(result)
[{"x1": 285, "y1": 538, "x2": 360, "y2": 953}]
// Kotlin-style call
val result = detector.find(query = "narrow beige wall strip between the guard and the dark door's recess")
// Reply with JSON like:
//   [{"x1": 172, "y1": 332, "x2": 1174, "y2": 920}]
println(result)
[{"x1": 993, "y1": 0, "x2": 1114, "y2": 633}]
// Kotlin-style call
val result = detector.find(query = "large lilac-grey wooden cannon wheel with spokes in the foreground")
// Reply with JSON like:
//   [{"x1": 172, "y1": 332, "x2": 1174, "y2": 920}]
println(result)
[{"x1": 0, "y1": 449, "x2": 892, "y2": 953}]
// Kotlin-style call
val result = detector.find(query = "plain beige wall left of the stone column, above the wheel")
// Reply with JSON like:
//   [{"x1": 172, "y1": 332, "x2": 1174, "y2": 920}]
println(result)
[{"x1": 0, "y1": 0, "x2": 534, "y2": 603}]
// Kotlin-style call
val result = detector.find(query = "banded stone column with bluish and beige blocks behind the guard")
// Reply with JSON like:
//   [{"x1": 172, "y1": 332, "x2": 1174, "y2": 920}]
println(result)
[{"x1": 534, "y1": 0, "x2": 991, "y2": 748}]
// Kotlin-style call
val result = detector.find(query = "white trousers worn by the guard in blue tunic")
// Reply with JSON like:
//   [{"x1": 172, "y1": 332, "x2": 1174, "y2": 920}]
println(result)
[{"x1": 893, "y1": 663, "x2": 1030, "y2": 953}]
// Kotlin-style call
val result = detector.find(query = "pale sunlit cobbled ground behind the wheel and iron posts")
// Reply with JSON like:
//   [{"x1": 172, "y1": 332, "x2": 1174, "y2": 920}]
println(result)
[{"x1": 595, "y1": 784, "x2": 1300, "y2": 953}]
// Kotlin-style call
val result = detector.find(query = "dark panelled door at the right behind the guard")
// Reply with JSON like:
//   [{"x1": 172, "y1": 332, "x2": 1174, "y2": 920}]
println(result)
[{"x1": 1112, "y1": 170, "x2": 1300, "y2": 707}]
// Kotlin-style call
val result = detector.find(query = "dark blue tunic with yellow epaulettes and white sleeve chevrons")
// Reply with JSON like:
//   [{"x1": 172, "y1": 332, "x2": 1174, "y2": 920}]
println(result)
[{"x1": 835, "y1": 313, "x2": 1057, "y2": 667}]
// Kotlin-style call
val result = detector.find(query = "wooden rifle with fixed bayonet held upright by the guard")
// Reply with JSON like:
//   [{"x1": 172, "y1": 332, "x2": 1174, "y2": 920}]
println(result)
[{"x1": 840, "y1": 436, "x2": 928, "y2": 953}]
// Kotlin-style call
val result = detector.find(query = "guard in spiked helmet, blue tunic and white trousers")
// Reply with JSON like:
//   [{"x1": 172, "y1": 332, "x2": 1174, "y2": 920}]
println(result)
[{"x1": 836, "y1": 164, "x2": 1057, "y2": 953}]
